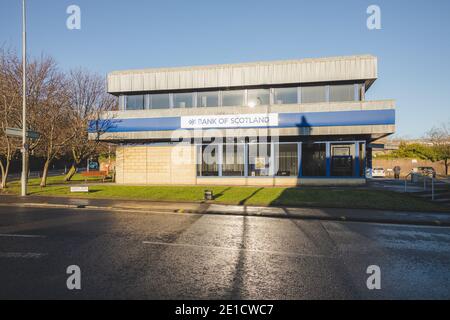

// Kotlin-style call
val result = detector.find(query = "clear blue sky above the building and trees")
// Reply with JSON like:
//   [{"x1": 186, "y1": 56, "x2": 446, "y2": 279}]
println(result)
[{"x1": 0, "y1": 0, "x2": 450, "y2": 138}]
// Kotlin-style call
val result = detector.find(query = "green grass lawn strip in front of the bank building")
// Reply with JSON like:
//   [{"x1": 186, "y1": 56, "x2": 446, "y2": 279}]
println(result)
[{"x1": 3, "y1": 175, "x2": 450, "y2": 212}]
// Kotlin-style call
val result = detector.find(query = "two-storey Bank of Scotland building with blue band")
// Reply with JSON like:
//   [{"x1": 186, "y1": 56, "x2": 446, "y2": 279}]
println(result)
[{"x1": 90, "y1": 55, "x2": 395, "y2": 186}]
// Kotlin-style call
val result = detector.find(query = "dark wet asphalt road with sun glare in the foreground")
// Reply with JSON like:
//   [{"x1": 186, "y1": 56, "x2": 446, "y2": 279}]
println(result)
[{"x1": 0, "y1": 206, "x2": 450, "y2": 299}]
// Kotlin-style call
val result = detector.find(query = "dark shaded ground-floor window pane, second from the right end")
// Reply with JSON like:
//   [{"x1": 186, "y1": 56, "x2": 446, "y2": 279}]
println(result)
[{"x1": 302, "y1": 143, "x2": 327, "y2": 177}]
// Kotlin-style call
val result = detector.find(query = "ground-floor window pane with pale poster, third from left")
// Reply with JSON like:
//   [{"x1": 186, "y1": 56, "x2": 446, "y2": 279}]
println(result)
[{"x1": 248, "y1": 143, "x2": 271, "y2": 177}]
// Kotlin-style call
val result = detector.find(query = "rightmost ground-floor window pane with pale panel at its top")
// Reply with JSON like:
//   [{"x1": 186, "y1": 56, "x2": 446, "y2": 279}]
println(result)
[{"x1": 331, "y1": 143, "x2": 355, "y2": 177}]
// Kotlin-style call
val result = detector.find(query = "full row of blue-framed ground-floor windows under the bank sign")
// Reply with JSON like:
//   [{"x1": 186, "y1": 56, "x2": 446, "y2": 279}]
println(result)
[{"x1": 197, "y1": 141, "x2": 366, "y2": 177}]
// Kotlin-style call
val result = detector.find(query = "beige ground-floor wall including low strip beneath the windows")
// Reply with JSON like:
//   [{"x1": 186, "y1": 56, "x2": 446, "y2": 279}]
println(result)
[{"x1": 116, "y1": 145, "x2": 365, "y2": 187}]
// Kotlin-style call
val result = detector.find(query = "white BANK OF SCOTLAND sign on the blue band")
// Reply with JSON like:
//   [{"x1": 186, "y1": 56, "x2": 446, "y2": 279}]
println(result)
[{"x1": 181, "y1": 113, "x2": 278, "y2": 129}]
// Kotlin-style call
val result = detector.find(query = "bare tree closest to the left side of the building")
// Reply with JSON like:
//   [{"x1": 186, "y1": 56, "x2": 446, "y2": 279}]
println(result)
[{"x1": 65, "y1": 69, "x2": 117, "y2": 181}]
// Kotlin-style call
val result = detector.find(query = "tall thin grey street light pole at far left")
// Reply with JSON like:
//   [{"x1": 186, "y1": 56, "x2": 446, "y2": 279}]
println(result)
[{"x1": 21, "y1": 0, "x2": 28, "y2": 196}]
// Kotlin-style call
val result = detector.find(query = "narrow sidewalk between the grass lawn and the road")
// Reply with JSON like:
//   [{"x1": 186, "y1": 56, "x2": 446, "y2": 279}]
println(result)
[{"x1": 0, "y1": 195, "x2": 450, "y2": 226}]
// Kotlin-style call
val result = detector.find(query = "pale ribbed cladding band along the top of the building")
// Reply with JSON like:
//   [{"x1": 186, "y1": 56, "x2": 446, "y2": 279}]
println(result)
[{"x1": 108, "y1": 55, "x2": 377, "y2": 93}]
